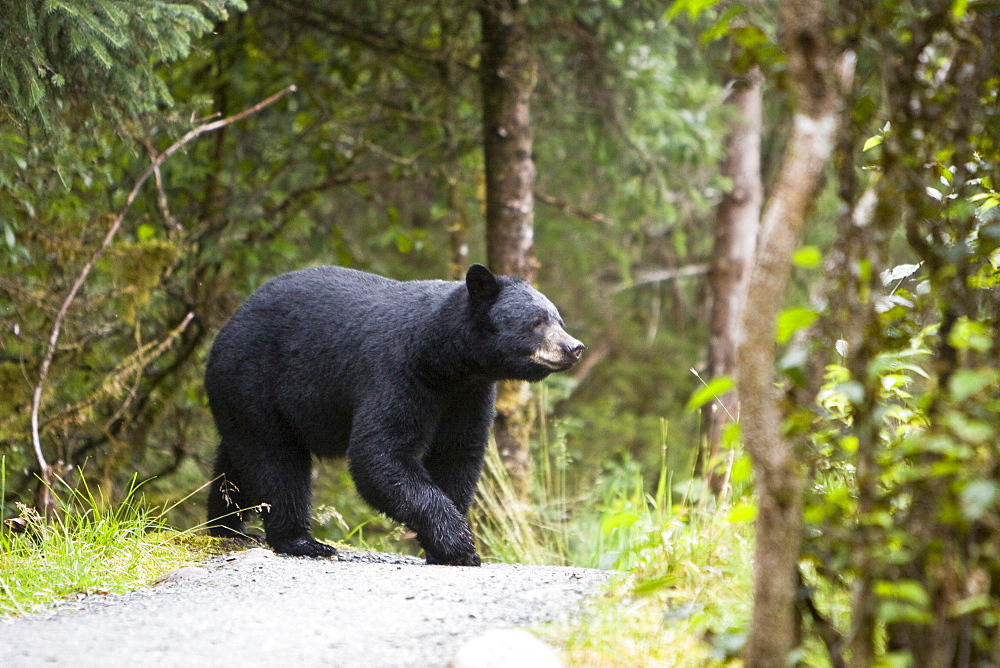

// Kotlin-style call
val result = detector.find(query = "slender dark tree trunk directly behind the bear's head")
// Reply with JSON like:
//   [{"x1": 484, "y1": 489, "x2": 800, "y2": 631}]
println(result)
[{"x1": 479, "y1": 0, "x2": 538, "y2": 491}]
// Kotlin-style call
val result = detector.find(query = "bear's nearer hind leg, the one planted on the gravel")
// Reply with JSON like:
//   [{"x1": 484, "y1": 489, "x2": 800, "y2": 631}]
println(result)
[{"x1": 255, "y1": 446, "x2": 337, "y2": 558}]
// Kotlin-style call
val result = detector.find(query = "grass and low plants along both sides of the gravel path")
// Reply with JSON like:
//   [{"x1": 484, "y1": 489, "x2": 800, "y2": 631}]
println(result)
[{"x1": 0, "y1": 434, "x2": 752, "y2": 666}]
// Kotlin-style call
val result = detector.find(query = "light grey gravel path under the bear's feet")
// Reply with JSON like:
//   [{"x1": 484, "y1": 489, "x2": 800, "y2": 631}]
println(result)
[{"x1": 0, "y1": 548, "x2": 608, "y2": 668}]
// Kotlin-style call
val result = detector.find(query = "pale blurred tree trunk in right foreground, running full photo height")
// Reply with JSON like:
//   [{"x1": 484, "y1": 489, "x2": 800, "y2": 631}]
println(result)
[{"x1": 737, "y1": 0, "x2": 853, "y2": 668}]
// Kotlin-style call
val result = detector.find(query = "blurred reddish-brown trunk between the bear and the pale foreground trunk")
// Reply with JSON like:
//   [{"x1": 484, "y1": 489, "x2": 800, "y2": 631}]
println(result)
[{"x1": 700, "y1": 66, "x2": 764, "y2": 494}]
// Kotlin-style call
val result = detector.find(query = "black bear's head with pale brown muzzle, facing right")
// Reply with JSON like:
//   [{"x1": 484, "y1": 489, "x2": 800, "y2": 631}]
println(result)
[{"x1": 465, "y1": 264, "x2": 584, "y2": 381}]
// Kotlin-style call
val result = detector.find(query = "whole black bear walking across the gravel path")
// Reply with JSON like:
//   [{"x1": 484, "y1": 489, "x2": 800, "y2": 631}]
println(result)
[{"x1": 205, "y1": 265, "x2": 584, "y2": 566}]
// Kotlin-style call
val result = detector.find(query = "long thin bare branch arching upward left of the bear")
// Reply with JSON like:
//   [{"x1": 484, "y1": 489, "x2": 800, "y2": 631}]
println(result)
[{"x1": 25, "y1": 86, "x2": 295, "y2": 516}]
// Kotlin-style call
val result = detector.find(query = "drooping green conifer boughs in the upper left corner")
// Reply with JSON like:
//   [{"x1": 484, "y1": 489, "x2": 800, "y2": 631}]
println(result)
[{"x1": 0, "y1": 0, "x2": 246, "y2": 127}]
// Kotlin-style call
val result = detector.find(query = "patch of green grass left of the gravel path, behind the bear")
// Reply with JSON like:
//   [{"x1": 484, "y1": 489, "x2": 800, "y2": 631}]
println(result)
[{"x1": 0, "y1": 463, "x2": 207, "y2": 616}]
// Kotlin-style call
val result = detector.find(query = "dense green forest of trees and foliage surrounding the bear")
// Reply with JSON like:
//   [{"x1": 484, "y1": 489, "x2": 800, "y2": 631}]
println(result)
[{"x1": 0, "y1": 0, "x2": 1000, "y2": 665}]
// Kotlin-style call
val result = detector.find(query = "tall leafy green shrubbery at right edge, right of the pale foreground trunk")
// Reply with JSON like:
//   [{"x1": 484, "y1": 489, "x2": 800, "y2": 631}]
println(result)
[{"x1": 805, "y1": 103, "x2": 1000, "y2": 661}]
